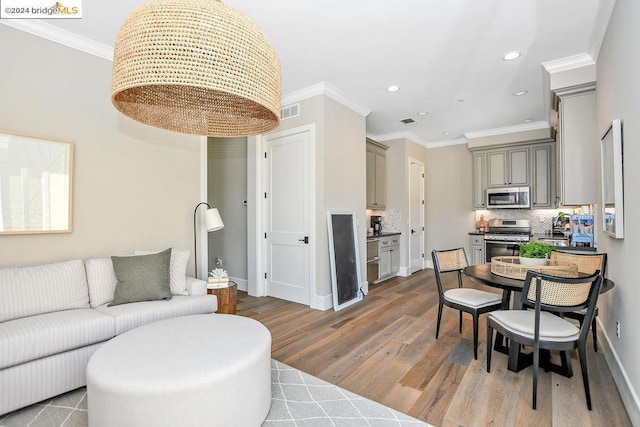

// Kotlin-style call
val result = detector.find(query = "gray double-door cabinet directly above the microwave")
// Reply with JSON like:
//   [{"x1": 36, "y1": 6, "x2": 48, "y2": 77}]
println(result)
[{"x1": 487, "y1": 147, "x2": 529, "y2": 187}]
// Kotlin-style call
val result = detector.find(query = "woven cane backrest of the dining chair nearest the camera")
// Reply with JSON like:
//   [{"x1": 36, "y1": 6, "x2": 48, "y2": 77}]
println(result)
[{"x1": 522, "y1": 270, "x2": 602, "y2": 338}]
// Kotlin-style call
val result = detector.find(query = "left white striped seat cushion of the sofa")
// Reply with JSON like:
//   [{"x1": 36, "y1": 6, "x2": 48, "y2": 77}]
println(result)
[{"x1": 0, "y1": 308, "x2": 115, "y2": 369}]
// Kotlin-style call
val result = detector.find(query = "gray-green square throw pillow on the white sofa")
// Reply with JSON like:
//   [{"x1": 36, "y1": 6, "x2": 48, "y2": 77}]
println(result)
[{"x1": 111, "y1": 248, "x2": 171, "y2": 305}]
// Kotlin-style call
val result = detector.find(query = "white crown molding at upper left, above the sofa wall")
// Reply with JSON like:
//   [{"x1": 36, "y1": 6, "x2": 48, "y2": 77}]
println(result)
[{"x1": 0, "y1": 19, "x2": 113, "y2": 61}]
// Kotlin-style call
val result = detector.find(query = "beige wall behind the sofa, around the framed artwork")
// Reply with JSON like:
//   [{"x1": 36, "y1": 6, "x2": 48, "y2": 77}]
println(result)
[{"x1": 0, "y1": 25, "x2": 200, "y2": 274}]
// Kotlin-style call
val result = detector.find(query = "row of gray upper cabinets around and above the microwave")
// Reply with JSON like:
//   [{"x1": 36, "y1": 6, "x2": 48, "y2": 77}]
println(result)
[{"x1": 472, "y1": 142, "x2": 556, "y2": 209}]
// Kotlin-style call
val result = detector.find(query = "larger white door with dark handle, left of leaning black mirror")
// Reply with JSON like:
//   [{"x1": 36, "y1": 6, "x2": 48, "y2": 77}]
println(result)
[{"x1": 265, "y1": 130, "x2": 311, "y2": 305}]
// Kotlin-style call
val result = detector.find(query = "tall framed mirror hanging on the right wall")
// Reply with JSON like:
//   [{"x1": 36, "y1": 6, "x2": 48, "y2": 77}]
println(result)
[{"x1": 600, "y1": 119, "x2": 624, "y2": 239}]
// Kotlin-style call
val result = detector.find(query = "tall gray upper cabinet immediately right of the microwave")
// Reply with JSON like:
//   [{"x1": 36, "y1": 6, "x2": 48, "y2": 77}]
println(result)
[{"x1": 531, "y1": 142, "x2": 556, "y2": 209}]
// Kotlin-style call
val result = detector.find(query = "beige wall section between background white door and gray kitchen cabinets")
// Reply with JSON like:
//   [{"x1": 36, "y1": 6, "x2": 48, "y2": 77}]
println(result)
[{"x1": 426, "y1": 144, "x2": 474, "y2": 260}]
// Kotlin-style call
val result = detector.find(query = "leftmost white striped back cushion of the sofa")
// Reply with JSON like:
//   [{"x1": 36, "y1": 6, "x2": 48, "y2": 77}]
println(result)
[{"x1": 0, "y1": 260, "x2": 89, "y2": 322}]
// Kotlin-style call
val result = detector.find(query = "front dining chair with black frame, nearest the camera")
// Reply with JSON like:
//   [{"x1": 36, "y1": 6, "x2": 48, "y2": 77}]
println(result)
[{"x1": 487, "y1": 271, "x2": 602, "y2": 410}]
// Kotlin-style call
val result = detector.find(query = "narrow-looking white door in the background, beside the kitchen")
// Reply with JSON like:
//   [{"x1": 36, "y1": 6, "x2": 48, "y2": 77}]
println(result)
[{"x1": 409, "y1": 160, "x2": 425, "y2": 273}]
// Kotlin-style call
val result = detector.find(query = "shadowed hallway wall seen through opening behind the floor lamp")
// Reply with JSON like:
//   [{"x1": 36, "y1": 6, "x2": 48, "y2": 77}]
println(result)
[{"x1": 208, "y1": 137, "x2": 248, "y2": 291}]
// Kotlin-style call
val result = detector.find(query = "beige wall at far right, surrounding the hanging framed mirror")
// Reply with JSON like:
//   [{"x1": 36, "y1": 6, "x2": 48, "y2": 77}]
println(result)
[{"x1": 596, "y1": 0, "x2": 640, "y2": 425}]
